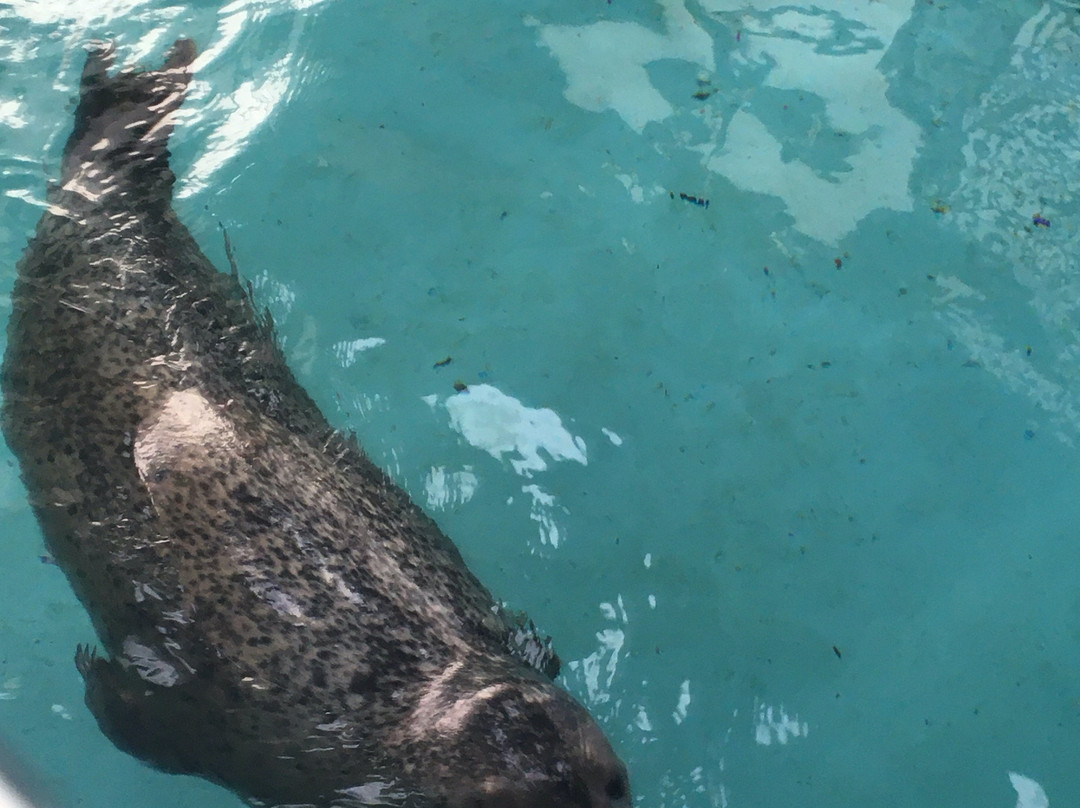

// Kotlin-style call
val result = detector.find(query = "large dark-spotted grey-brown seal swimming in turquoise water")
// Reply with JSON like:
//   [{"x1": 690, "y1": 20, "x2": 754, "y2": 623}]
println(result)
[{"x1": 2, "y1": 39, "x2": 631, "y2": 808}]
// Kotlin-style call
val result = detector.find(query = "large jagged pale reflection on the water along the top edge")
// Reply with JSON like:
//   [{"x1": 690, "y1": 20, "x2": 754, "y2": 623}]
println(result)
[{"x1": 528, "y1": 0, "x2": 921, "y2": 243}]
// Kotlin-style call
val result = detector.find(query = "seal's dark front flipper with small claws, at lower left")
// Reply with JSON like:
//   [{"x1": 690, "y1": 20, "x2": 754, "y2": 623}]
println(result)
[{"x1": 75, "y1": 645, "x2": 198, "y2": 773}]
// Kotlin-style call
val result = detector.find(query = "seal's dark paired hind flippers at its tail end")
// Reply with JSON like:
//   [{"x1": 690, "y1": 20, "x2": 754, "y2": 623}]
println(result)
[{"x1": 63, "y1": 39, "x2": 197, "y2": 192}]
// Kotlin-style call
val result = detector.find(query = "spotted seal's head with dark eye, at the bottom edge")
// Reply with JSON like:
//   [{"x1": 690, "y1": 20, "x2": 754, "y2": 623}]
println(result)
[{"x1": 406, "y1": 663, "x2": 631, "y2": 808}]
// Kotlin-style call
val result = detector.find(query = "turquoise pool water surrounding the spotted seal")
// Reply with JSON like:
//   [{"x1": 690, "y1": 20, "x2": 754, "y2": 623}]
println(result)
[{"x1": 0, "y1": 0, "x2": 1080, "y2": 808}]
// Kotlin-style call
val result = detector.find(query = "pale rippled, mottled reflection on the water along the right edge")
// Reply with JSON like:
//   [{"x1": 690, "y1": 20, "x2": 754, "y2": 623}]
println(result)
[{"x1": 935, "y1": 4, "x2": 1080, "y2": 445}]
